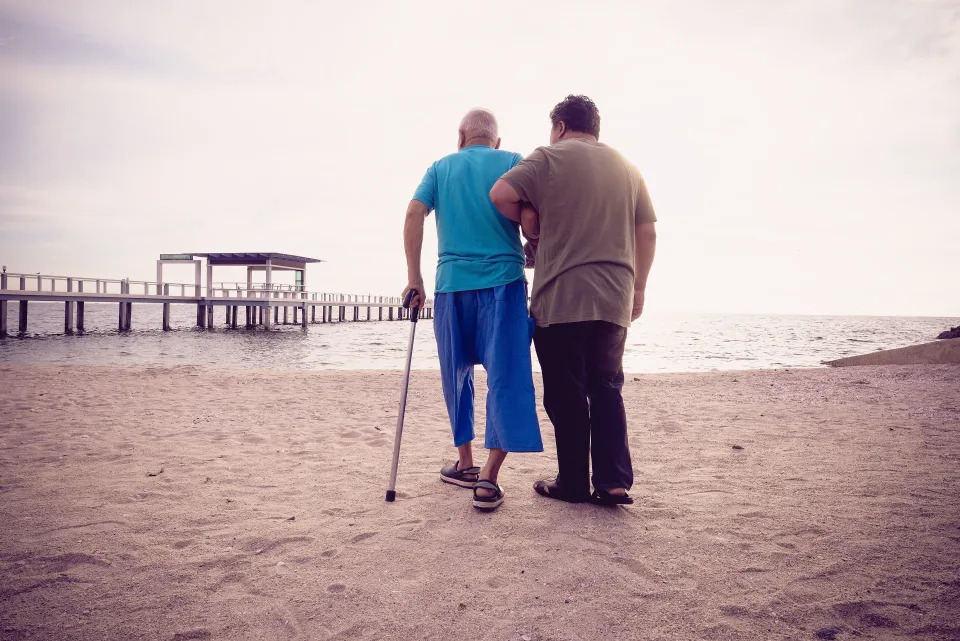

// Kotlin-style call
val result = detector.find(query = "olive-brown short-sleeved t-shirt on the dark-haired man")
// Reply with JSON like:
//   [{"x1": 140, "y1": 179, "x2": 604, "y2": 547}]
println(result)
[{"x1": 503, "y1": 138, "x2": 657, "y2": 327}]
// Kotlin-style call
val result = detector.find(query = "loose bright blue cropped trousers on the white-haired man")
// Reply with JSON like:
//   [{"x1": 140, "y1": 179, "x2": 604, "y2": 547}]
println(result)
[{"x1": 433, "y1": 280, "x2": 543, "y2": 452}]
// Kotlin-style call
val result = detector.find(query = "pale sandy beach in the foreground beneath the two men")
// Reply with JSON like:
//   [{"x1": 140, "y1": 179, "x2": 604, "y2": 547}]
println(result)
[{"x1": 0, "y1": 364, "x2": 960, "y2": 641}]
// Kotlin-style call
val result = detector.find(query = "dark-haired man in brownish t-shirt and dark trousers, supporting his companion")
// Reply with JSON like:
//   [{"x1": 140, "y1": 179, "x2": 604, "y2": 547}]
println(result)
[{"x1": 490, "y1": 96, "x2": 656, "y2": 505}]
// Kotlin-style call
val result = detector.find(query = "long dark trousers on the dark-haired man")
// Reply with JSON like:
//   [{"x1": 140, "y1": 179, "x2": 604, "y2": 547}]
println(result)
[{"x1": 534, "y1": 321, "x2": 633, "y2": 498}]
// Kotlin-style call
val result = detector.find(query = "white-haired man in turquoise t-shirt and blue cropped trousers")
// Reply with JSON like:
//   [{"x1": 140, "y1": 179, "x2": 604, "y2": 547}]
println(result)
[{"x1": 404, "y1": 109, "x2": 543, "y2": 510}]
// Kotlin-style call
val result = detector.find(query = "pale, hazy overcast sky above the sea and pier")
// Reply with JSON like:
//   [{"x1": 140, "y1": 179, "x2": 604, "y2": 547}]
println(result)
[{"x1": 0, "y1": 0, "x2": 960, "y2": 316}]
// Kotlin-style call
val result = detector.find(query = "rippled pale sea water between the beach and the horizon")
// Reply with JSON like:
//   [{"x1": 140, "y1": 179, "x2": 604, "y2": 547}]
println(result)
[{"x1": 0, "y1": 303, "x2": 958, "y2": 373}]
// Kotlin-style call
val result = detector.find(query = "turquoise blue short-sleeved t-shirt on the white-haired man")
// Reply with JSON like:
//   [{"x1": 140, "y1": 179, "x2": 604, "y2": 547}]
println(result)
[{"x1": 413, "y1": 146, "x2": 525, "y2": 294}]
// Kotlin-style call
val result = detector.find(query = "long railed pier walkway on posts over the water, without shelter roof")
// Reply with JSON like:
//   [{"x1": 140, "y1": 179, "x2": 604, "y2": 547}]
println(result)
[{"x1": 0, "y1": 273, "x2": 433, "y2": 337}]
